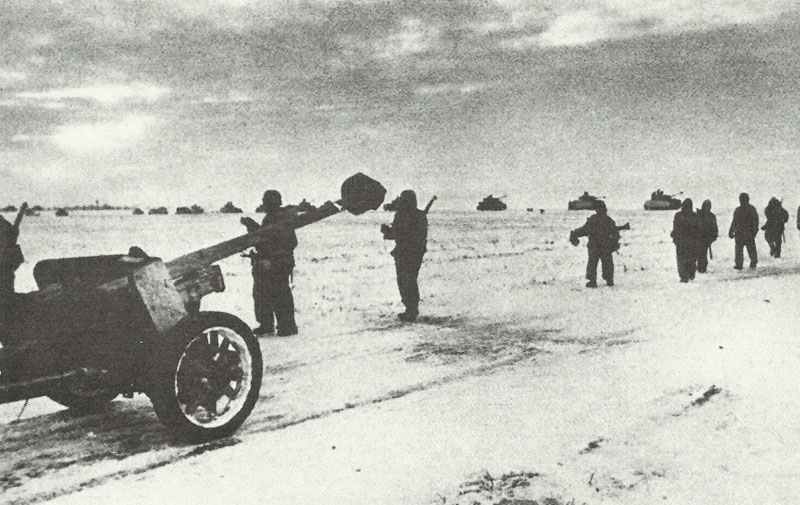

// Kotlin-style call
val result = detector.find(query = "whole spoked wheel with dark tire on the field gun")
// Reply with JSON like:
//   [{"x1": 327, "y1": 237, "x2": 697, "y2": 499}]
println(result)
[{"x1": 149, "y1": 312, "x2": 262, "y2": 441}]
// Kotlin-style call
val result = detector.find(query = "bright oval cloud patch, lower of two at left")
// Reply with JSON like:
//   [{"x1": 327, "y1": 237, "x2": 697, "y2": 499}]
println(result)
[{"x1": 49, "y1": 114, "x2": 158, "y2": 156}]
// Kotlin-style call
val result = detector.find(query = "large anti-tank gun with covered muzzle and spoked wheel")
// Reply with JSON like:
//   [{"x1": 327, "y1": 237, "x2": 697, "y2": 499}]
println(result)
[{"x1": 0, "y1": 174, "x2": 386, "y2": 441}]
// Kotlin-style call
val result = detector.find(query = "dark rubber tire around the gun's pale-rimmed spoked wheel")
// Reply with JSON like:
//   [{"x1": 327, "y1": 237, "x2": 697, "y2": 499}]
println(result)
[{"x1": 147, "y1": 312, "x2": 264, "y2": 443}]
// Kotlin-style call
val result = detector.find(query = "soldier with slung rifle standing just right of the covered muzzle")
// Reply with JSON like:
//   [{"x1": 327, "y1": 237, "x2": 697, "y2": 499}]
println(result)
[{"x1": 381, "y1": 189, "x2": 428, "y2": 322}]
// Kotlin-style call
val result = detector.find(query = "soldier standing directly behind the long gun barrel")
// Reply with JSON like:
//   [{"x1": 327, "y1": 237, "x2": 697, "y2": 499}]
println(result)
[{"x1": 241, "y1": 189, "x2": 297, "y2": 337}]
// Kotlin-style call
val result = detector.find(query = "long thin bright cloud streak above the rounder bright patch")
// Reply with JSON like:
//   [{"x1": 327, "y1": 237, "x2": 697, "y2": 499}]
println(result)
[{"x1": 16, "y1": 83, "x2": 170, "y2": 105}]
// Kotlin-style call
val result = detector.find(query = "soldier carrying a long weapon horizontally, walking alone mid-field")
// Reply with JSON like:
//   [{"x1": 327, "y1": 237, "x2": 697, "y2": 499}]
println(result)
[{"x1": 569, "y1": 201, "x2": 619, "y2": 288}]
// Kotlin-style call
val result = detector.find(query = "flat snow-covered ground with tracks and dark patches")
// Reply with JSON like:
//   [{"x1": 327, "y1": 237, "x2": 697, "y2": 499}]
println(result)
[{"x1": 0, "y1": 207, "x2": 800, "y2": 505}]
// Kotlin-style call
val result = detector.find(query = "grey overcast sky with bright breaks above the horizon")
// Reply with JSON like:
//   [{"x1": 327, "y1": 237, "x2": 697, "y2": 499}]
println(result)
[{"x1": 0, "y1": 0, "x2": 800, "y2": 208}]
